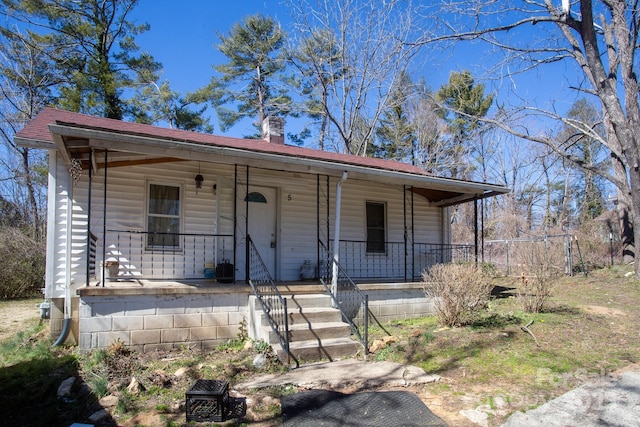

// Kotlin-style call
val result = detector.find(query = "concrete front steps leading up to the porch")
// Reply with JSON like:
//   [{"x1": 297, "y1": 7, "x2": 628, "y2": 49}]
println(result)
[{"x1": 249, "y1": 294, "x2": 361, "y2": 362}]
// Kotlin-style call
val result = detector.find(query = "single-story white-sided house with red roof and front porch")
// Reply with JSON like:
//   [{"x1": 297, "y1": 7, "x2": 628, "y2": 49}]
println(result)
[{"x1": 15, "y1": 108, "x2": 508, "y2": 357}]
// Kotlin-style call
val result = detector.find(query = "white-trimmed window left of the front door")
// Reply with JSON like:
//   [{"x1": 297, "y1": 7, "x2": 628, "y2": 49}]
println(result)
[{"x1": 147, "y1": 183, "x2": 181, "y2": 250}]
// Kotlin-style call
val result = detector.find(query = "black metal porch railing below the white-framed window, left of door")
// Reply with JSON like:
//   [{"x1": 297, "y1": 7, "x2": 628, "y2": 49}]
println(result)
[{"x1": 99, "y1": 229, "x2": 233, "y2": 280}]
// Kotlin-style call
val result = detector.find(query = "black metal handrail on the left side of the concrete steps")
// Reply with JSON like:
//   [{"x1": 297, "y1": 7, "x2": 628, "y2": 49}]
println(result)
[{"x1": 247, "y1": 236, "x2": 300, "y2": 368}]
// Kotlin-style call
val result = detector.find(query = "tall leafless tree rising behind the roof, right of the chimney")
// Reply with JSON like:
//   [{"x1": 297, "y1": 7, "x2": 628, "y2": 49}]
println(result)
[{"x1": 289, "y1": 0, "x2": 415, "y2": 156}]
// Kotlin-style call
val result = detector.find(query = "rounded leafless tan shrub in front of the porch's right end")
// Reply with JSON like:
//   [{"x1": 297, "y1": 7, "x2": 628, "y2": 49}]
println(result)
[{"x1": 422, "y1": 264, "x2": 493, "y2": 326}]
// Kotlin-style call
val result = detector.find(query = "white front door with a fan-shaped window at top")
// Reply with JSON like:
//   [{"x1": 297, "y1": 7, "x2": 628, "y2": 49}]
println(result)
[{"x1": 238, "y1": 186, "x2": 278, "y2": 280}]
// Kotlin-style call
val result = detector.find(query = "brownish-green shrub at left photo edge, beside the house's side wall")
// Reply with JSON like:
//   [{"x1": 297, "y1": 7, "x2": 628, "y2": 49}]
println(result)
[{"x1": 0, "y1": 227, "x2": 45, "y2": 299}]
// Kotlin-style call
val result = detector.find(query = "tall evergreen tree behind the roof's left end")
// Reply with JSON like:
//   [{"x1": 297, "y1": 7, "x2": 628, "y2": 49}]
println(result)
[{"x1": 3, "y1": 0, "x2": 160, "y2": 119}]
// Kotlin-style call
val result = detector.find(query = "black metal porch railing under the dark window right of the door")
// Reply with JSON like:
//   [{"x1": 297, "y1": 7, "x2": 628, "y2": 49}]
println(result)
[{"x1": 330, "y1": 240, "x2": 474, "y2": 281}]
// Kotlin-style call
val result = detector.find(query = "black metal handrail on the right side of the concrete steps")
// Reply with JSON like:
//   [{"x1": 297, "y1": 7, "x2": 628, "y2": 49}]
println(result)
[{"x1": 318, "y1": 242, "x2": 369, "y2": 357}]
